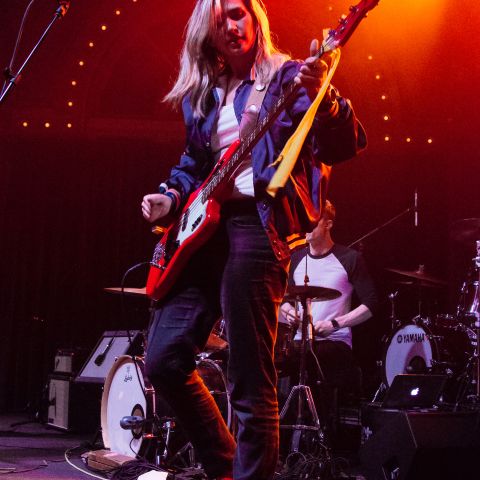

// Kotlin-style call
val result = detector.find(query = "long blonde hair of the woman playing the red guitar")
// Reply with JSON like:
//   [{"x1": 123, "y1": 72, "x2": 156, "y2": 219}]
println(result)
[{"x1": 163, "y1": 0, "x2": 289, "y2": 117}]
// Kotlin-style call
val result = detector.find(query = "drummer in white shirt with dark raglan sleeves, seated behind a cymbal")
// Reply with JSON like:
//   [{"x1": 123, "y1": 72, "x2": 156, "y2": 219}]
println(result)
[{"x1": 280, "y1": 200, "x2": 378, "y2": 432}]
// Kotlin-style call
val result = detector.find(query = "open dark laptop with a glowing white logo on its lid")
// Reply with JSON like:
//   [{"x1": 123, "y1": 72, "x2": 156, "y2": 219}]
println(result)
[{"x1": 381, "y1": 374, "x2": 447, "y2": 409}]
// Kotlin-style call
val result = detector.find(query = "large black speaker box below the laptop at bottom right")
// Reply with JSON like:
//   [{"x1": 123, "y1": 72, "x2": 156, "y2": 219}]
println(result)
[{"x1": 359, "y1": 411, "x2": 480, "y2": 480}]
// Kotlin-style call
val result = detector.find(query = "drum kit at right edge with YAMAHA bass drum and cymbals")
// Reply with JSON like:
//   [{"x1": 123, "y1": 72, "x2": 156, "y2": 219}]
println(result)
[{"x1": 374, "y1": 219, "x2": 480, "y2": 409}]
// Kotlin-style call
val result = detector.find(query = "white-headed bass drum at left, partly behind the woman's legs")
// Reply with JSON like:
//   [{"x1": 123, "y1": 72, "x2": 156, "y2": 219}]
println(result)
[{"x1": 101, "y1": 355, "x2": 235, "y2": 459}]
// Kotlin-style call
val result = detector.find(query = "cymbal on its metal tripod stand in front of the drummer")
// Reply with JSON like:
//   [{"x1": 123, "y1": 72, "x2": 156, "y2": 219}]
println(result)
[{"x1": 280, "y1": 284, "x2": 341, "y2": 461}]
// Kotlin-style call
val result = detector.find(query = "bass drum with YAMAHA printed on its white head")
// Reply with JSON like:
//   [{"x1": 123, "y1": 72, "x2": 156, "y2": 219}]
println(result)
[{"x1": 383, "y1": 322, "x2": 475, "y2": 386}]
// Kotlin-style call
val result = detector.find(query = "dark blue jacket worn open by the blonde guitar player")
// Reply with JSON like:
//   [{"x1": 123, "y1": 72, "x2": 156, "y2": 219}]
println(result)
[{"x1": 159, "y1": 60, "x2": 366, "y2": 261}]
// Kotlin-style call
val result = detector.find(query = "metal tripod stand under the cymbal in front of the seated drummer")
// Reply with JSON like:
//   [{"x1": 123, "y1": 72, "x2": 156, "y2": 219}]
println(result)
[{"x1": 280, "y1": 295, "x2": 328, "y2": 455}]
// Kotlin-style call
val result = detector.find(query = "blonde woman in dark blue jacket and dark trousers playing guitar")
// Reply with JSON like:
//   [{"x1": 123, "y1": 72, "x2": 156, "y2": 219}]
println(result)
[{"x1": 142, "y1": 0, "x2": 366, "y2": 480}]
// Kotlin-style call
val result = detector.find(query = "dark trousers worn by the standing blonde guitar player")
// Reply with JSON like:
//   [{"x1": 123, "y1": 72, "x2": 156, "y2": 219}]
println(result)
[{"x1": 146, "y1": 201, "x2": 287, "y2": 480}]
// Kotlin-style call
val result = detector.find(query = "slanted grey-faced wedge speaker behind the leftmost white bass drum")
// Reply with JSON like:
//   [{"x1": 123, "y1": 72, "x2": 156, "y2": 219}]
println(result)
[{"x1": 75, "y1": 330, "x2": 143, "y2": 384}]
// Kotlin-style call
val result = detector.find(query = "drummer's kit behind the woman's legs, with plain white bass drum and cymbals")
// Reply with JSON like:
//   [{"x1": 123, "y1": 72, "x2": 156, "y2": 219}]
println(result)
[{"x1": 101, "y1": 286, "x2": 340, "y2": 468}]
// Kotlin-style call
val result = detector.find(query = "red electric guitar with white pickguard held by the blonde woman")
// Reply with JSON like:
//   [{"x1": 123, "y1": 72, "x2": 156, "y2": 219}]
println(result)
[{"x1": 146, "y1": 0, "x2": 379, "y2": 300}]
